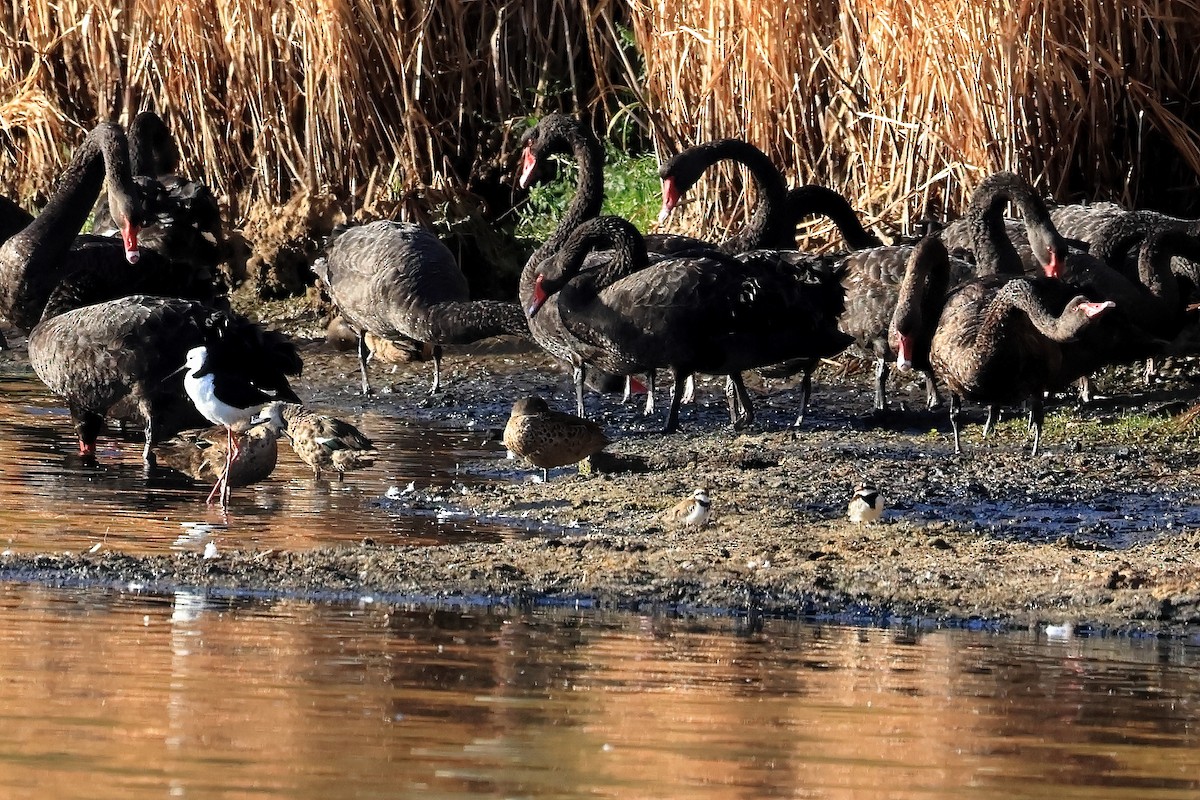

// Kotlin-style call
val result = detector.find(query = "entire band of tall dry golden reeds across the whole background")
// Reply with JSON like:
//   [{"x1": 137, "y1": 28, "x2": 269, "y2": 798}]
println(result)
[{"x1": 0, "y1": 0, "x2": 1200, "y2": 255}]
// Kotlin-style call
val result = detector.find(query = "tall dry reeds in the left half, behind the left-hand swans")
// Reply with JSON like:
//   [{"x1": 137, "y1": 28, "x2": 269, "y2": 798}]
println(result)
[{"x1": 0, "y1": 0, "x2": 614, "y2": 231}]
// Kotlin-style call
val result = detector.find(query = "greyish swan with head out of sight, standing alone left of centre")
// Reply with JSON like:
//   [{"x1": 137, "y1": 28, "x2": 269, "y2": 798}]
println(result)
[{"x1": 312, "y1": 219, "x2": 529, "y2": 395}]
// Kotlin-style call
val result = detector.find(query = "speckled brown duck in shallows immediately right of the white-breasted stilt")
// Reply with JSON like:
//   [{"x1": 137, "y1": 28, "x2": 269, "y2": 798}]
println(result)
[{"x1": 252, "y1": 401, "x2": 379, "y2": 481}]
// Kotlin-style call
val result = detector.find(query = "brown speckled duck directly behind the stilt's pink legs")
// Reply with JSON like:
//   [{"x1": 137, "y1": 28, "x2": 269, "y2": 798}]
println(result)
[{"x1": 154, "y1": 425, "x2": 280, "y2": 486}]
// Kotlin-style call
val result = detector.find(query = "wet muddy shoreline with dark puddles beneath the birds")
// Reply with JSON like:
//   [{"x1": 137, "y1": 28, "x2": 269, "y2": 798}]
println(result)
[{"x1": 7, "y1": 303, "x2": 1200, "y2": 633}]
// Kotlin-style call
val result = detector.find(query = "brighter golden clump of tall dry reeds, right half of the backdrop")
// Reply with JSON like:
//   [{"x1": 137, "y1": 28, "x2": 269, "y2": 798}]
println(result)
[{"x1": 632, "y1": 0, "x2": 1200, "y2": 244}]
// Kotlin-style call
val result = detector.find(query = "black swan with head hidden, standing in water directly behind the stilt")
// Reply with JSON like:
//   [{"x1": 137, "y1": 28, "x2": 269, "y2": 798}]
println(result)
[{"x1": 29, "y1": 295, "x2": 301, "y2": 471}]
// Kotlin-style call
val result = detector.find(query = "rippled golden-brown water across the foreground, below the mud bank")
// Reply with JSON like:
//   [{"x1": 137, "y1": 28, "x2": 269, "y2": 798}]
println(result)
[{"x1": 0, "y1": 584, "x2": 1200, "y2": 799}]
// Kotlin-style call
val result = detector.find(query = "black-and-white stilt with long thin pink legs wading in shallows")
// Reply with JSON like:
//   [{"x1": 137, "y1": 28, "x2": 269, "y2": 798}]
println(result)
[{"x1": 184, "y1": 345, "x2": 285, "y2": 506}]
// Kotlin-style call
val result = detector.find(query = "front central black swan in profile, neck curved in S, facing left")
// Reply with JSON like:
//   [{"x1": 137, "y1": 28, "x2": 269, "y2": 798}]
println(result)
[{"x1": 530, "y1": 217, "x2": 851, "y2": 432}]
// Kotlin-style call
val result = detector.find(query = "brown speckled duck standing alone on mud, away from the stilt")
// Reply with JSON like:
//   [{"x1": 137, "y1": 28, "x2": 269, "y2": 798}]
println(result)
[{"x1": 504, "y1": 395, "x2": 608, "y2": 479}]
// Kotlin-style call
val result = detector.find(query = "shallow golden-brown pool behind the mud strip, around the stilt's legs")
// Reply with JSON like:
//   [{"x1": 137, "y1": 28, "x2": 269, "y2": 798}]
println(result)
[{"x1": 0, "y1": 361, "x2": 514, "y2": 554}]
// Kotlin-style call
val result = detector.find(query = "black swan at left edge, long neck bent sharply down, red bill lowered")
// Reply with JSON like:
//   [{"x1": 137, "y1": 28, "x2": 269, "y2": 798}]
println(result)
[{"x1": 0, "y1": 124, "x2": 214, "y2": 330}]
